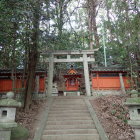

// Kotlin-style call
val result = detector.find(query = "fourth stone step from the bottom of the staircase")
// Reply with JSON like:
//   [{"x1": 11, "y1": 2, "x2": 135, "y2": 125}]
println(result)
[{"x1": 47, "y1": 120, "x2": 93, "y2": 125}]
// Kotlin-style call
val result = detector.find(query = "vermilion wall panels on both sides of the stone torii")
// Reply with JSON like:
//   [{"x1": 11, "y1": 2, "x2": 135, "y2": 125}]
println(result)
[{"x1": 0, "y1": 77, "x2": 130, "y2": 93}]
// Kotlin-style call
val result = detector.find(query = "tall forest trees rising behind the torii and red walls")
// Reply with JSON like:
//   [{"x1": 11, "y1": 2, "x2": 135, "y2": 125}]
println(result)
[{"x1": 0, "y1": 0, "x2": 140, "y2": 109}]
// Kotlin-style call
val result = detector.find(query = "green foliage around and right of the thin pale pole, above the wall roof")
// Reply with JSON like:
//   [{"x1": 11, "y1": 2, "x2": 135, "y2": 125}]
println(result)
[{"x1": 96, "y1": 0, "x2": 140, "y2": 89}]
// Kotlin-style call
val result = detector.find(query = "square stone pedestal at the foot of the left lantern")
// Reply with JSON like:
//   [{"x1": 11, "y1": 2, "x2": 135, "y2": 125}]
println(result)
[{"x1": 0, "y1": 130, "x2": 11, "y2": 140}]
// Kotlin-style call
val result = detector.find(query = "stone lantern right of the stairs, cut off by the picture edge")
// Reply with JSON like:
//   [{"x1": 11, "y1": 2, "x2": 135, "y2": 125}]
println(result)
[{"x1": 125, "y1": 97, "x2": 140, "y2": 140}]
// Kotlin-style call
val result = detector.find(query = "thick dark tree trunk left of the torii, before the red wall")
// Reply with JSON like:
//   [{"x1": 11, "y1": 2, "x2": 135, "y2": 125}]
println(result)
[{"x1": 25, "y1": 1, "x2": 40, "y2": 111}]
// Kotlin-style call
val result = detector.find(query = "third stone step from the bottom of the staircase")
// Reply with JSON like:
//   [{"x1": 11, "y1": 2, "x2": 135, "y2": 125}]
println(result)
[{"x1": 45, "y1": 124, "x2": 95, "y2": 130}]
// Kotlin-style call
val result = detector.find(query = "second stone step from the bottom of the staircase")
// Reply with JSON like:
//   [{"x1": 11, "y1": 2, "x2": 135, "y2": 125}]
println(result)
[{"x1": 43, "y1": 129, "x2": 98, "y2": 135}]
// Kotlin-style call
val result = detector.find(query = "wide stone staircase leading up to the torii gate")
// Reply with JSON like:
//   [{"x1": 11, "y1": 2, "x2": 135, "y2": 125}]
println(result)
[{"x1": 41, "y1": 97, "x2": 100, "y2": 140}]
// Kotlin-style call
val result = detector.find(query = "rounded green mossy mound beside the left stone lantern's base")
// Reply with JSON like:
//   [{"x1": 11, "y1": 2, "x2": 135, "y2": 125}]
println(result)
[{"x1": 11, "y1": 124, "x2": 29, "y2": 140}]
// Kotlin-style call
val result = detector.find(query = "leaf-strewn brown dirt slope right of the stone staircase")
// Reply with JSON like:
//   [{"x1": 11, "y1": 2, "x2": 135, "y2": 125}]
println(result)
[{"x1": 90, "y1": 95, "x2": 134, "y2": 140}]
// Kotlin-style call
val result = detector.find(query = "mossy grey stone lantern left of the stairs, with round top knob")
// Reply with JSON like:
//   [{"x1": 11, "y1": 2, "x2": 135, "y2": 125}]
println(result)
[{"x1": 0, "y1": 92, "x2": 21, "y2": 140}]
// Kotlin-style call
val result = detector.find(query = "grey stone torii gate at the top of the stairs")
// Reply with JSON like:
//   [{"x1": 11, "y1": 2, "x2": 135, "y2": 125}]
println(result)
[{"x1": 42, "y1": 49, "x2": 98, "y2": 96}]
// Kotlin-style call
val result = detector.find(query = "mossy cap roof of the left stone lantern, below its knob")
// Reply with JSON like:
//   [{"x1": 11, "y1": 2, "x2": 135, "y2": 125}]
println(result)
[{"x1": 0, "y1": 99, "x2": 21, "y2": 107}]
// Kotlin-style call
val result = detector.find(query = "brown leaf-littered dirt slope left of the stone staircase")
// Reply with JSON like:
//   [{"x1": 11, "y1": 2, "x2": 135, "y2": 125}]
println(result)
[{"x1": 16, "y1": 100, "x2": 47, "y2": 140}]
